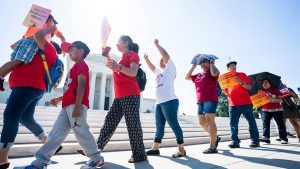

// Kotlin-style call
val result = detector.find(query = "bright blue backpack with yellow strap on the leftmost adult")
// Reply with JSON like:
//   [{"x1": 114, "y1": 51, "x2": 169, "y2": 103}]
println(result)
[{"x1": 38, "y1": 50, "x2": 64, "y2": 93}]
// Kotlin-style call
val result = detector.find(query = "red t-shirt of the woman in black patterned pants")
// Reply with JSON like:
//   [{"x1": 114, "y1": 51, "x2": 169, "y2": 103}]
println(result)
[{"x1": 113, "y1": 51, "x2": 140, "y2": 98}]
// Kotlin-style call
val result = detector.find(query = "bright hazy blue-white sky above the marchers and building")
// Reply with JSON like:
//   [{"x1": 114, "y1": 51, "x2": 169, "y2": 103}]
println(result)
[{"x1": 0, "y1": 0, "x2": 300, "y2": 114}]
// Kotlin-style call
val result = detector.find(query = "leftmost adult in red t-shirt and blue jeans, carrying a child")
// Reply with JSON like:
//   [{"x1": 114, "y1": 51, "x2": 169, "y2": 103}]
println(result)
[{"x1": 0, "y1": 25, "x2": 57, "y2": 168}]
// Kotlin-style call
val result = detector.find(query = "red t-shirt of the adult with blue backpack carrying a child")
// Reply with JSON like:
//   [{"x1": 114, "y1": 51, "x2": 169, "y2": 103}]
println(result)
[{"x1": 9, "y1": 42, "x2": 57, "y2": 90}]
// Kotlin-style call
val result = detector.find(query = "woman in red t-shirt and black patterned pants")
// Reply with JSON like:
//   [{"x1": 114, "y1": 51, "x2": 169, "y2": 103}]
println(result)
[{"x1": 97, "y1": 36, "x2": 147, "y2": 163}]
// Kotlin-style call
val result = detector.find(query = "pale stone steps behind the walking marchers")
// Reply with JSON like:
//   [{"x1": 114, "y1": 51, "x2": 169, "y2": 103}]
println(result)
[{"x1": 0, "y1": 105, "x2": 277, "y2": 157}]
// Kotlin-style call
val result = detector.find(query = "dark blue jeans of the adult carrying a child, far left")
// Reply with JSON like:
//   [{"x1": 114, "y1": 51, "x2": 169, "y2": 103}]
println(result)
[{"x1": 0, "y1": 87, "x2": 45, "y2": 148}]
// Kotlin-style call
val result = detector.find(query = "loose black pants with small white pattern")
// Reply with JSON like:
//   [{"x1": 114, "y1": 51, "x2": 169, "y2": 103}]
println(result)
[{"x1": 97, "y1": 96, "x2": 147, "y2": 159}]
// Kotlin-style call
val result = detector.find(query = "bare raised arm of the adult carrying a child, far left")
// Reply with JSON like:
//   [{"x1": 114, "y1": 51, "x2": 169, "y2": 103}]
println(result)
[{"x1": 33, "y1": 25, "x2": 56, "y2": 50}]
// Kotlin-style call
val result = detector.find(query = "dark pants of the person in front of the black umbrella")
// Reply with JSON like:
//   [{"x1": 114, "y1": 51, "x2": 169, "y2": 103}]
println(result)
[{"x1": 261, "y1": 111, "x2": 287, "y2": 140}]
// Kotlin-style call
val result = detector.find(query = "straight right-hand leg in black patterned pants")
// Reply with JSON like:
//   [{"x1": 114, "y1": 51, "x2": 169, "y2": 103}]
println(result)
[{"x1": 120, "y1": 96, "x2": 147, "y2": 163}]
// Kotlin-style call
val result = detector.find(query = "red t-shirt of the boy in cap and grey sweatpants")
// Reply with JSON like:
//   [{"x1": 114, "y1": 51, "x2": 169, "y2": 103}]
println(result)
[{"x1": 62, "y1": 61, "x2": 90, "y2": 108}]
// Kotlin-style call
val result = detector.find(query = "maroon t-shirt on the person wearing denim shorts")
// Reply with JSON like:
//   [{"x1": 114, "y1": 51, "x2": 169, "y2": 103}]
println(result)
[{"x1": 191, "y1": 71, "x2": 218, "y2": 103}]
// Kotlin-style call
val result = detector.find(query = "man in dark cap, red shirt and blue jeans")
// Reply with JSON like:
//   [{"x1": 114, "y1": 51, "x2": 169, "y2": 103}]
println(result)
[{"x1": 223, "y1": 61, "x2": 260, "y2": 148}]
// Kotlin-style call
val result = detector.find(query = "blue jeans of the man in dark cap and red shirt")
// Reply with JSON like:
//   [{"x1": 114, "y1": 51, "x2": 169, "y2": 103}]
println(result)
[{"x1": 229, "y1": 104, "x2": 259, "y2": 144}]
